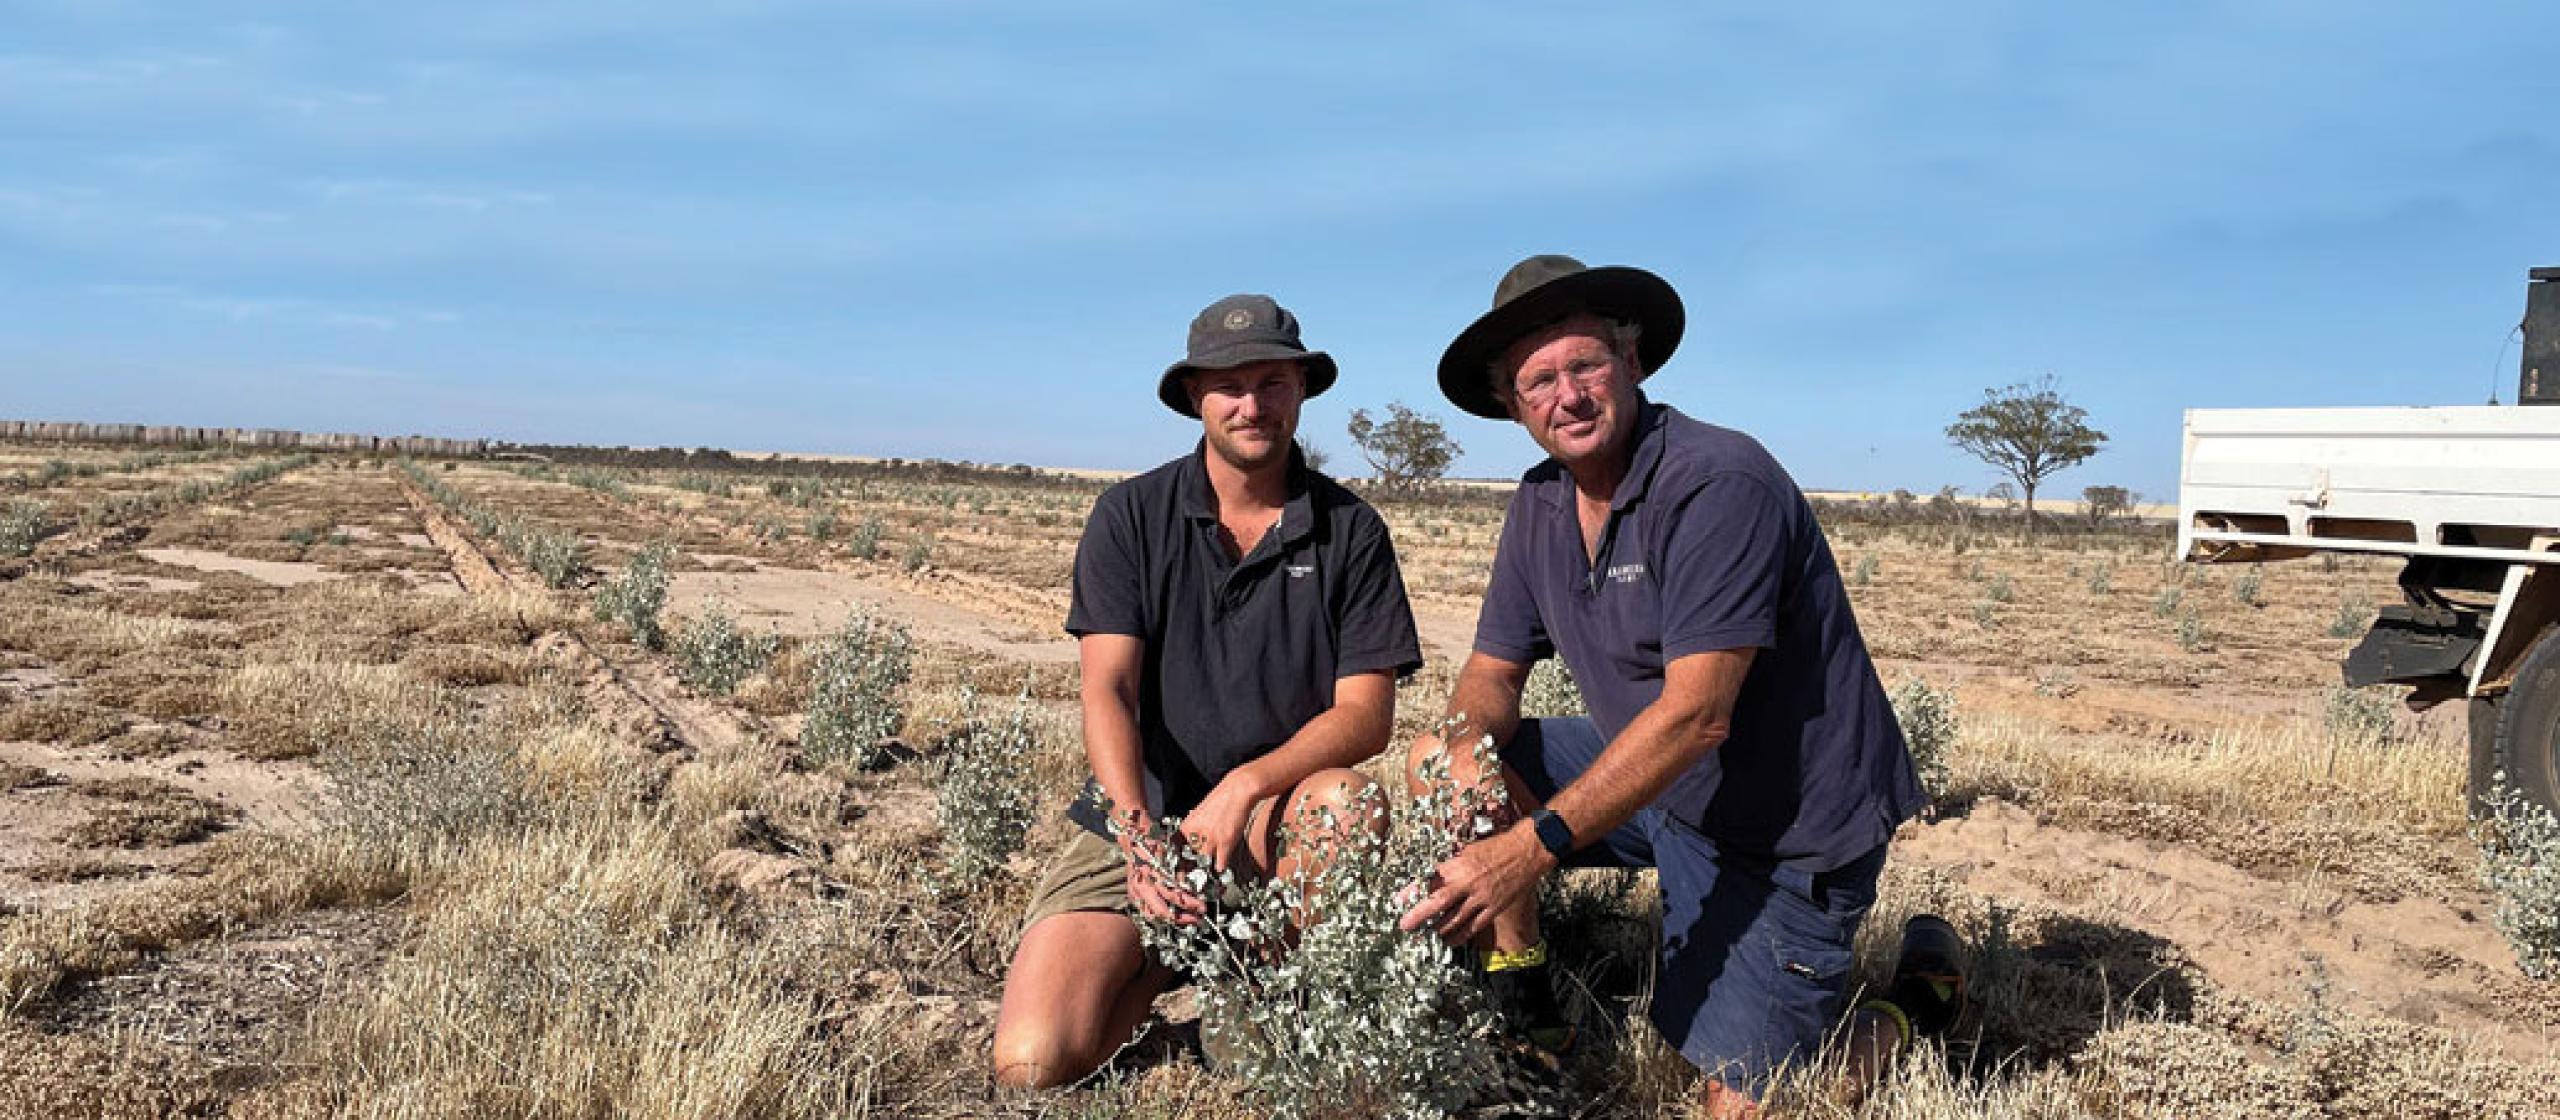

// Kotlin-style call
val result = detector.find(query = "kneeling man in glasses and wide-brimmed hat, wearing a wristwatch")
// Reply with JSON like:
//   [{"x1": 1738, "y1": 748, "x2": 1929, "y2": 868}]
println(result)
[{"x1": 1403, "y1": 256, "x2": 1964, "y2": 1115}]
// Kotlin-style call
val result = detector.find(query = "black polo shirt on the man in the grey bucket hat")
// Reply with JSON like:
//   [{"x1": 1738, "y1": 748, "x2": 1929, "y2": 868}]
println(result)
[{"x1": 1068, "y1": 447, "x2": 1423, "y2": 831}]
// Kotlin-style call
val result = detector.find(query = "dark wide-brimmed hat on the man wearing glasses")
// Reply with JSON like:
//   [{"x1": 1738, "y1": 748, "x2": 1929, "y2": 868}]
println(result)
[{"x1": 1439, "y1": 253, "x2": 1687, "y2": 419}]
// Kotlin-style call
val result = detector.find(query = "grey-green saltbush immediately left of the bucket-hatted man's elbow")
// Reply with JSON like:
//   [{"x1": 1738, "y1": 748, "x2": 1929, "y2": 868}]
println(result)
[{"x1": 934, "y1": 685, "x2": 1039, "y2": 890}]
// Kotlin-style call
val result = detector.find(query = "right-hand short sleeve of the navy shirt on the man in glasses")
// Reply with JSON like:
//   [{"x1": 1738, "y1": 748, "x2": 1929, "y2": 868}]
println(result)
[{"x1": 1661, "y1": 473, "x2": 1797, "y2": 660}]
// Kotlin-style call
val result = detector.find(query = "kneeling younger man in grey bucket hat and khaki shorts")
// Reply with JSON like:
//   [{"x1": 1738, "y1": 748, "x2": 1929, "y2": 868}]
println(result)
[{"x1": 993, "y1": 294, "x2": 1421, "y2": 1087}]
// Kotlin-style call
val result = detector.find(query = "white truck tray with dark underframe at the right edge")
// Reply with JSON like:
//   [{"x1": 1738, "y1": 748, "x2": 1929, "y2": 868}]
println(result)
[{"x1": 2179, "y1": 268, "x2": 2560, "y2": 811}]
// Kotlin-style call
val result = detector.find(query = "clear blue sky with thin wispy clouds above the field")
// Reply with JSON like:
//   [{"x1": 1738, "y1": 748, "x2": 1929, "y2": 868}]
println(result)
[{"x1": 0, "y1": 0, "x2": 2560, "y2": 496}]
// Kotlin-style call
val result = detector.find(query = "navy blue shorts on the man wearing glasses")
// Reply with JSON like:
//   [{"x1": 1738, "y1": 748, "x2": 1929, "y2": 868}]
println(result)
[{"x1": 1503, "y1": 719, "x2": 1884, "y2": 1097}]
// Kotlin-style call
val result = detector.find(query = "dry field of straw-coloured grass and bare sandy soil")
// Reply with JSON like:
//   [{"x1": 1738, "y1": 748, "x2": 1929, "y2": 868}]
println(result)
[{"x1": 0, "y1": 447, "x2": 2560, "y2": 1117}]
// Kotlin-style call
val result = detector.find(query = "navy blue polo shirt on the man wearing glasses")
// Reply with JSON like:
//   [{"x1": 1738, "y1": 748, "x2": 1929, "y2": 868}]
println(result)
[{"x1": 1475, "y1": 404, "x2": 1925, "y2": 872}]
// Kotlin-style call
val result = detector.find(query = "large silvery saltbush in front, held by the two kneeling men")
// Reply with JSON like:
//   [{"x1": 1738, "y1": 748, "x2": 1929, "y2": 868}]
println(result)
[{"x1": 1121, "y1": 739, "x2": 1503, "y2": 1117}]
